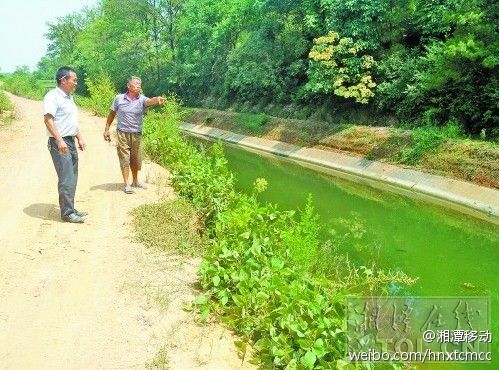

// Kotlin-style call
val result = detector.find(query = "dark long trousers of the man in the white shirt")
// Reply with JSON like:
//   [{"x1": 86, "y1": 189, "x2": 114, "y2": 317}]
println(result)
[{"x1": 48, "y1": 136, "x2": 78, "y2": 218}]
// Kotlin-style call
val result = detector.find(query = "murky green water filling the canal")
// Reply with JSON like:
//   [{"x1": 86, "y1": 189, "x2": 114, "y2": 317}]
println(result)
[{"x1": 189, "y1": 137, "x2": 499, "y2": 370}]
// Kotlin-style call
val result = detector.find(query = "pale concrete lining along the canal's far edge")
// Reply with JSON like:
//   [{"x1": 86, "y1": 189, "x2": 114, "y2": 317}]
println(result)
[{"x1": 181, "y1": 122, "x2": 499, "y2": 225}]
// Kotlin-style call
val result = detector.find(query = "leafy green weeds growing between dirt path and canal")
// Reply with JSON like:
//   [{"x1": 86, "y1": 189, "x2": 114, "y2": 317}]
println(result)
[{"x1": 144, "y1": 100, "x2": 414, "y2": 369}]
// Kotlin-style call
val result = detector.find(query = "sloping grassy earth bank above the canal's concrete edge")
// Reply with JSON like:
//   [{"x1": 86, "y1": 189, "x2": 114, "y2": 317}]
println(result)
[{"x1": 185, "y1": 109, "x2": 499, "y2": 188}]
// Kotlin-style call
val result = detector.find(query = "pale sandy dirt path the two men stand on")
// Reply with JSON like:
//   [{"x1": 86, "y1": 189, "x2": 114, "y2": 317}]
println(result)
[{"x1": 0, "y1": 96, "x2": 250, "y2": 369}]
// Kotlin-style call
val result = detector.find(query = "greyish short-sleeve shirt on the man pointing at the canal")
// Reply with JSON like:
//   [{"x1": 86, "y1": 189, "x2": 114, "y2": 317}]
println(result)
[{"x1": 111, "y1": 93, "x2": 147, "y2": 133}]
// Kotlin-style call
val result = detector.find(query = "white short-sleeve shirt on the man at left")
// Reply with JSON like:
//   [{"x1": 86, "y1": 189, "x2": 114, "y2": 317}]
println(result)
[{"x1": 43, "y1": 87, "x2": 78, "y2": 137}]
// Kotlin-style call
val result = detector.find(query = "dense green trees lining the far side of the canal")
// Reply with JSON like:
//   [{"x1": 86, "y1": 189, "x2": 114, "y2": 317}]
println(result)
[{"x1": 34, "y1": 0, "x2": 499, "y2": 137}]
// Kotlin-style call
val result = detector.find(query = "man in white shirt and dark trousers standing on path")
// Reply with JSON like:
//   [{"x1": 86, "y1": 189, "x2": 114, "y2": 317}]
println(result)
[{"x1": 43, "y1": 67, "x2": 87, "y2": 223}]
